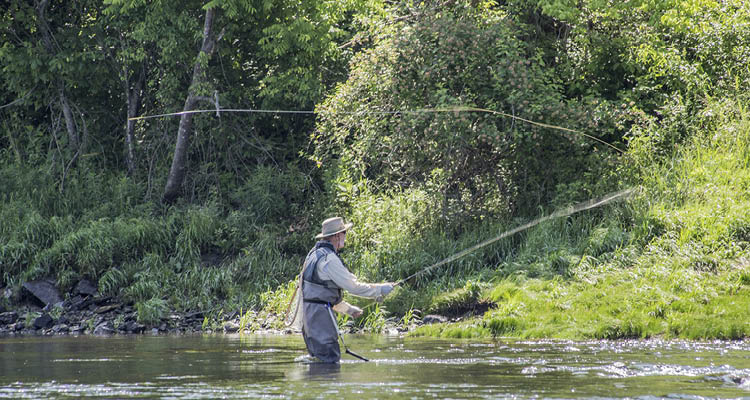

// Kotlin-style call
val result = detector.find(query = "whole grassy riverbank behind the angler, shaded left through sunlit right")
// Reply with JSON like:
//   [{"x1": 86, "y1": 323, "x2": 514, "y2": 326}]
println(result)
[{"x1": 0, "y1": 99, "x2": 750, "y2": 339}]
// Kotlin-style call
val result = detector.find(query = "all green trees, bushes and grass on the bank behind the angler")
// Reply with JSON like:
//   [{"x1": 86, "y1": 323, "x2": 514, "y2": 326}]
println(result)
[{"x1": 0, "y1": 0, "x2": 750, "y2": 338}]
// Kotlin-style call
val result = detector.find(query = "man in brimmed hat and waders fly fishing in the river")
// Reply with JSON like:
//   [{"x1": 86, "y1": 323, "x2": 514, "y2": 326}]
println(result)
[{"x1": 300, "y1": 217, "x2": 394, "y2": 363}]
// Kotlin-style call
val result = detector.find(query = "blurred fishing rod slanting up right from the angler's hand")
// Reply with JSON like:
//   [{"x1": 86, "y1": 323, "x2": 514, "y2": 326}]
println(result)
[{"x1": 393, "y1": 188, "x2": 635, "y2": 286}]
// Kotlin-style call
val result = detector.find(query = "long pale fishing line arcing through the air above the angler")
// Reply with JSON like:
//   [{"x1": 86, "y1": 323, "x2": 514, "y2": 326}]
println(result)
[{"x1": 128, "y1": 106, "x2": 625, "y2": 153}]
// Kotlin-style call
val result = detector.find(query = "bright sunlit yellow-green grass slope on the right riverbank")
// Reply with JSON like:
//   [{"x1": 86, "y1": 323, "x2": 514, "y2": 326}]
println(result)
[{"x1": 414, "y1": 97, "x2": 750, "y2": 339}]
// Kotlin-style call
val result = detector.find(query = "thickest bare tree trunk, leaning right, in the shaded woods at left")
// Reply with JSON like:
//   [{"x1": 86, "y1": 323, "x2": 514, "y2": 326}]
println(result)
[{"x1": 162, "y1": 8, "x2": 221, "y2": 203}]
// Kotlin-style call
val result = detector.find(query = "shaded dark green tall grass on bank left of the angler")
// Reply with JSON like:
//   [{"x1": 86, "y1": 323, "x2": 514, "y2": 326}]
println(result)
[{"x1": 0, "y1": 165, "x2": 317, "y2": 324}]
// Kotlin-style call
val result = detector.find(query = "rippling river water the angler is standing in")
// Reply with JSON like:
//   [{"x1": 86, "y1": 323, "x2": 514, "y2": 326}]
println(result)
[{"x1": 0, "y1": 335, "x2": 750, "y2": 399}]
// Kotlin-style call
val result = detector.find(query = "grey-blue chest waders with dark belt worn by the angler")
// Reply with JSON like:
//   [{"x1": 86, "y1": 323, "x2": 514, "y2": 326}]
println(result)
[{"x1": 302, "y1": 241, "x2": 364, "y2": 363}]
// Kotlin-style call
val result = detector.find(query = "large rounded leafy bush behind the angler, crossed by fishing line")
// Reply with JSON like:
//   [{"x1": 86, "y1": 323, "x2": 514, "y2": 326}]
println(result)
[{"x1": 312, "y1": 3, "x2": 607, "y2": 221}]
